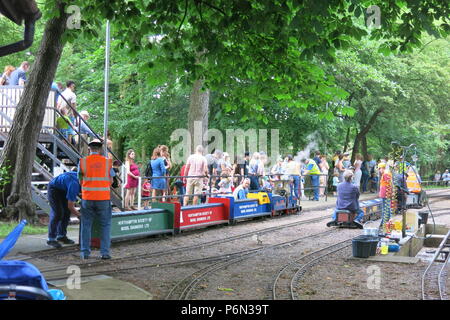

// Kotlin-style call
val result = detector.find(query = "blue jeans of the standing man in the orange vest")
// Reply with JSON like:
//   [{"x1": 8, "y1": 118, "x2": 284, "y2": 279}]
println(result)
[{"x1": 80, "y1": 200, "x2": 112, "y2": 256}]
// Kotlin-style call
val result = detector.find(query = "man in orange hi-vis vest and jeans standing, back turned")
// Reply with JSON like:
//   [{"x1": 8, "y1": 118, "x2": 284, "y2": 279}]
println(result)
[{"x1": 79, "y1": 139, "x2": 115, "y2": 260}]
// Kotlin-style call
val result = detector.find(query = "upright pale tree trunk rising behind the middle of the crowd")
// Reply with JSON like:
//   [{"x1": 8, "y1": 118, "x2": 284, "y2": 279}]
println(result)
[{"x1": 188, "y1": 80, "x2": 211, "y2": 153}]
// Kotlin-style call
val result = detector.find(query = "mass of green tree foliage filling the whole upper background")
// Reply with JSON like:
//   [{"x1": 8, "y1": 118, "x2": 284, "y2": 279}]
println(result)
[{"x1": 0, "y1": 0, "x2": 450, "y2": 172}]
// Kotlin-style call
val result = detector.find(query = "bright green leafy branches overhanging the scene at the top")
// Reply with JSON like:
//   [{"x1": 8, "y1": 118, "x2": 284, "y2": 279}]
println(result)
[{"x1": 37, "y1": 0, "x2": 449, "y2": 118}]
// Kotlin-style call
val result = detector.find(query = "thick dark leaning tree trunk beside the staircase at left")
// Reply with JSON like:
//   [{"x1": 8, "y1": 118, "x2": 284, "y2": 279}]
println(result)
[{"x1": 0, "y1": 3, "x2": 67, "y2": 222}]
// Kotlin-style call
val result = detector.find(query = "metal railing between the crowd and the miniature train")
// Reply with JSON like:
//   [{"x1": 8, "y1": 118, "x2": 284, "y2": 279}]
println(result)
[{"x1": 121, "y1": 171, "x2": 328, "y2": 210}]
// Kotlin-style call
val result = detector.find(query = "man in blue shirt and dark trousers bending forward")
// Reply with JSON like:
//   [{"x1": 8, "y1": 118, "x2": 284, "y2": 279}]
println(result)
[{"x1": 47, "y1": 171, "x2": 81, "y2": 249}]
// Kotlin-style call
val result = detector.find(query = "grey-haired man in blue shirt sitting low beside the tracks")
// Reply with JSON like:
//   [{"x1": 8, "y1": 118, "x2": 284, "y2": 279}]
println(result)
[{"x1": 327, "y1": 170, "x2": 364, "y2": 228}]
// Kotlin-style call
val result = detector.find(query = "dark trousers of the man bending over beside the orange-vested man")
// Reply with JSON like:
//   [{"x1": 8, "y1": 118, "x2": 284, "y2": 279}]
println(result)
[{"x1": 47, "y1": 185, "x2": 70, "y2": 241}]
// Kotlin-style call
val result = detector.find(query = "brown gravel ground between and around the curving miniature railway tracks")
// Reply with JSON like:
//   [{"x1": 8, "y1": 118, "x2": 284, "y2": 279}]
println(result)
[{"x1": 39, "y1": 189, "x2": 450, "y2": 300}]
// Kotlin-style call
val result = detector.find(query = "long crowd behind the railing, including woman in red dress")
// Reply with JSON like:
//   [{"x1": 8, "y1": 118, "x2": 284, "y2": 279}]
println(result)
[{"x1": 118, "y1": 145, "x2": 406, "y2": 209}]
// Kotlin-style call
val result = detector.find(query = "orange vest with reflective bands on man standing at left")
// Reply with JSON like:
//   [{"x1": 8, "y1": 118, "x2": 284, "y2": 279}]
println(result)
[{"x1": 80, "y1": 154, "x2": 112, "y2": 200}]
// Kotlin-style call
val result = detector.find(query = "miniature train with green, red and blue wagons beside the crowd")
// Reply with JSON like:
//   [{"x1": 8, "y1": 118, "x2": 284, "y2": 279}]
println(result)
[{"x1": 92, "y1": 192, "x2": 381, "y2": 247}]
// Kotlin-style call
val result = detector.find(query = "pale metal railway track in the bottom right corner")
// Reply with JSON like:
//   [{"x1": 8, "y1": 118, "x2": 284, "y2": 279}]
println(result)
[{"x1": 422, "y1": 231, "x2": 450, "y2": 300}]
